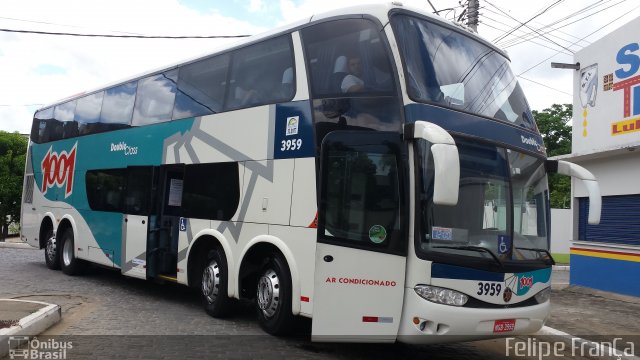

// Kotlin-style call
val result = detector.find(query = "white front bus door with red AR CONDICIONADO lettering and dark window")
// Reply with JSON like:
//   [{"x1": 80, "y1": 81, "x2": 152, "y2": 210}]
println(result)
[{"x1": 312, "y1": 131, "x2": 407, "y2": 342}]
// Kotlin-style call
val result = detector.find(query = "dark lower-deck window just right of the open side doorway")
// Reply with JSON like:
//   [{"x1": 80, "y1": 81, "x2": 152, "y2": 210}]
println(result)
[{"x1": 182, "y1": 162, "x2": 240, "y2": 220}]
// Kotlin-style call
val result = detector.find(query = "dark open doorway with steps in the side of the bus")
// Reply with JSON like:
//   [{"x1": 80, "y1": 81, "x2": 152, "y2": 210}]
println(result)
[{"x1": 147, "y1": 164, "x2": 184, "y2": 281}]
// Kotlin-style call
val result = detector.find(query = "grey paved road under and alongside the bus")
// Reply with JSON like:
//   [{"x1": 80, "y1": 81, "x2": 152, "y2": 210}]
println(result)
[{"x1": 0, "y1": 248, "x2": 596, "y2": 360}]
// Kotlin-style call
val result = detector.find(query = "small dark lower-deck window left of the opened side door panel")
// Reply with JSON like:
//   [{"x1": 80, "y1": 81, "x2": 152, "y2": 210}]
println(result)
[{"x1": 86, "y1": 169, "x2": 127, "y2": 212}]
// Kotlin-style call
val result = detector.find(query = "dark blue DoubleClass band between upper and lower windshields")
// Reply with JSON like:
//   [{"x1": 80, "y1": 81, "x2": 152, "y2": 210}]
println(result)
[{"x1": 405, "y1": 104, "x2": 545, "y2": 155}]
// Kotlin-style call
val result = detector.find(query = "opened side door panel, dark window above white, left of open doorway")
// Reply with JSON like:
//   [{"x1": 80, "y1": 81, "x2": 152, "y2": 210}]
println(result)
[{"x1": 121, "y1": 166, "x2": 155, "y2": 279}]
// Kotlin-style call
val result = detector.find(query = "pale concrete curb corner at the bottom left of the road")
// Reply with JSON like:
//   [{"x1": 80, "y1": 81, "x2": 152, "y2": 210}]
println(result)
[{"x1": 0, "y1": 299, "x2": 62, "y2": 358}]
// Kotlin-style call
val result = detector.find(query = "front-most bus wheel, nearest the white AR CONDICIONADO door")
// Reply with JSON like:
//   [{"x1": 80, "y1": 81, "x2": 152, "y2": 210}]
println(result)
[{"x1": 255, "y1": 255, "x2": 293, "y2": 335}]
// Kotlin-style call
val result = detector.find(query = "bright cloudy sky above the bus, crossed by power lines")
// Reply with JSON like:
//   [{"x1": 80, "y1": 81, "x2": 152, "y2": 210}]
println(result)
[{"x1": 0, "y1": 0, "x2": 640, "y2": 133}]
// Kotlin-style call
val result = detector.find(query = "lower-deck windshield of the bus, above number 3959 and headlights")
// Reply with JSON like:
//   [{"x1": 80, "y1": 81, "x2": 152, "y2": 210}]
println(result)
[{"x1": 416, "y1": 138, "x2": 549, "y2": 264}]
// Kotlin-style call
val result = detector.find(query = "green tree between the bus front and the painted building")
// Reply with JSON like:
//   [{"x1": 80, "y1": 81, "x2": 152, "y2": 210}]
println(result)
[{"x1": 533, "y1": 104, "x2": 573, "y2": 209}]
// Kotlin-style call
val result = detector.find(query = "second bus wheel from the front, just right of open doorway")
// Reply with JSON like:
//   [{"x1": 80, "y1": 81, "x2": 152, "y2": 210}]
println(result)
[{"x1": 200, "y1": 249, "x2": 233, "y2": 318}]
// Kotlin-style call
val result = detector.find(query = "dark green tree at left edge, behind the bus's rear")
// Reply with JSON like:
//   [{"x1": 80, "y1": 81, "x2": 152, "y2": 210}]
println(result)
[{"x1": 0, "y1": 131, "x2": 27, "y2": 241}]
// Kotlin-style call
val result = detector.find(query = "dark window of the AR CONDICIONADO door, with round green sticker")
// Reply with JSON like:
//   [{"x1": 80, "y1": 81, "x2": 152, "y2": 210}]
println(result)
[{"x1": 319, "y1": 132, "x2": 404, "y2": 251}]
